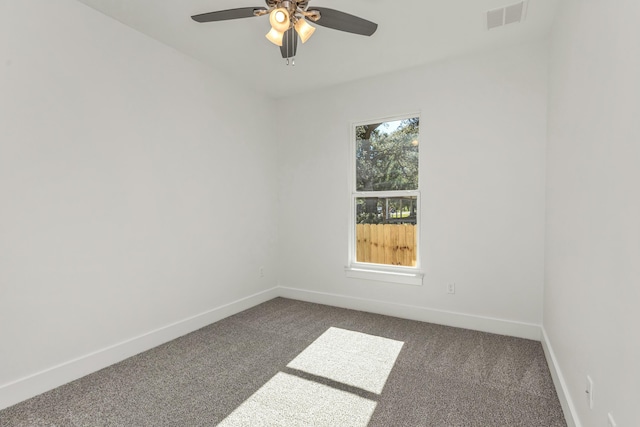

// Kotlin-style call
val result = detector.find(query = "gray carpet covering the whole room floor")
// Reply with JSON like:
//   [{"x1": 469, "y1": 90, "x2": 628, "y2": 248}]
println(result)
[{"x1": 0, "y1": 298, "x2": 566, "y2": 427}]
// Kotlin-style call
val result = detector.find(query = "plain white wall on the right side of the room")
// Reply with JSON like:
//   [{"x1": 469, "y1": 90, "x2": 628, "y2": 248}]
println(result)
[{"x1": 544, "y1": 0, "x2": 640, "y2": 427}]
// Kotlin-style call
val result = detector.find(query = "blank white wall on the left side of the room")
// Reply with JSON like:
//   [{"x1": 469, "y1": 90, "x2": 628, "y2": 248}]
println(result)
[{"x1": 0, "y1": 0, "x2": 277, "y2": 408}]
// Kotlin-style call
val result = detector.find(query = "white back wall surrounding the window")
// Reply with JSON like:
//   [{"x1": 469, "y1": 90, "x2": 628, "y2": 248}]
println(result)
[{"x1": 279, "y1": 42, "x2": 547, "y2": 337}]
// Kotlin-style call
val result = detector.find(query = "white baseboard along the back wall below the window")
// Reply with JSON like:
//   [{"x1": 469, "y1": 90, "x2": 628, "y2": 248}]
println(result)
[{"x1": 278, "y1": 287, "x2": 540, "y2": 341}]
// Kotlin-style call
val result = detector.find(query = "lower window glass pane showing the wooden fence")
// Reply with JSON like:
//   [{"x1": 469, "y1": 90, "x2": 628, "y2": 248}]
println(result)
[{"x1": 355, "y1": 196, "x2": 418, "y2": 267}]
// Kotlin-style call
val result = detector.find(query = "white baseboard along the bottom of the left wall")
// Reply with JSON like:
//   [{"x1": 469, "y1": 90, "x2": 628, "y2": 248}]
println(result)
[{"x1": 0, "y1": 288, "x2": 279, "y2": 410}]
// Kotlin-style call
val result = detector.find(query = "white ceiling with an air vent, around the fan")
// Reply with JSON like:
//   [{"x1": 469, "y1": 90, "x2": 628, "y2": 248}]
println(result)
[{"x1": 74, "y1": 0, "x2": 558, "y2": 97}]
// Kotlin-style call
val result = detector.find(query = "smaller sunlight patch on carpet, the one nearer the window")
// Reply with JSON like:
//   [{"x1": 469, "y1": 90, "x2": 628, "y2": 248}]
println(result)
[{"x1": 287, "y1": 327, "x2": 404, "y2": 394}]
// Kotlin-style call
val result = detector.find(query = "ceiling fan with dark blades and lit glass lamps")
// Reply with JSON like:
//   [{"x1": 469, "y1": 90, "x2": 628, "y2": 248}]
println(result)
[{"x1": 191, "y1": 0, "x2": 378, "y2": 65}]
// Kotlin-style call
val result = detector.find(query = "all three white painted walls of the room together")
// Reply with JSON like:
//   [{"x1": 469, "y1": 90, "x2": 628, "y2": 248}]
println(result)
[{"x1": 8, "y1": 0, "x2": 640, "y2": 427}]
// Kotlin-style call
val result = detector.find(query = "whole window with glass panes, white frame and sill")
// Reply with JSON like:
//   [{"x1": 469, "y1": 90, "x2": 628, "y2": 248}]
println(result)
[{"x1": 347, "y1": 116, "x2": 422, "y2": 284}]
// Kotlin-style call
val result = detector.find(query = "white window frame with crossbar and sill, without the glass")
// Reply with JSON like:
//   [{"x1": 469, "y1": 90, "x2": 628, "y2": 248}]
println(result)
[{"x1": 345, "y1": 113, "x2": 424, "y2": 286}]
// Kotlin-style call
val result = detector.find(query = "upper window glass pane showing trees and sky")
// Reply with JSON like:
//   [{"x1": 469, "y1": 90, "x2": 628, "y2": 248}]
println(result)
[{"x1": 356, "y1": 117, "x2": 420, "y2": 191}]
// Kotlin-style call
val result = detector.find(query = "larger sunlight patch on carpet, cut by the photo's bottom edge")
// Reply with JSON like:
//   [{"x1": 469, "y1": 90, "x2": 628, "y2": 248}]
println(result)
[{"x1": 218, "y1": 372, "x2": 377, "y2": 427}]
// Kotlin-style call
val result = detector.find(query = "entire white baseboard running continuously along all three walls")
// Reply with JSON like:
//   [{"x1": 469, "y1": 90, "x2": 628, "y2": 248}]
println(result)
[{"x1": 0, "y1": 287, "x2": 544, "y2": 414}]
